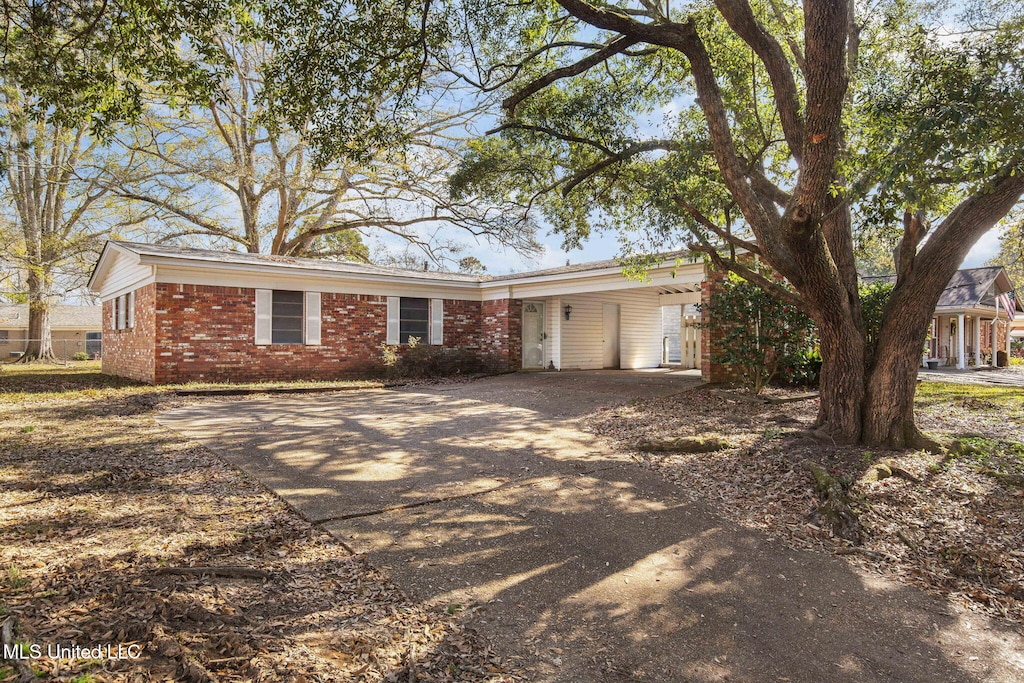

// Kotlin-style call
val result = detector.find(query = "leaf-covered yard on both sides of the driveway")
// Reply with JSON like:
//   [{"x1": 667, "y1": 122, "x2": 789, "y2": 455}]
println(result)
[{"x1": 0, "y1": 364, "x2": 1024, "y2": 683}]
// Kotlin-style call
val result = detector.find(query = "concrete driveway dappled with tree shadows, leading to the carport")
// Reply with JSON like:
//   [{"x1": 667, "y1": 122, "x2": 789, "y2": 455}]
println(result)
[{"x1": 153, "y1": 373, "x2": 1024, "y2": 683}]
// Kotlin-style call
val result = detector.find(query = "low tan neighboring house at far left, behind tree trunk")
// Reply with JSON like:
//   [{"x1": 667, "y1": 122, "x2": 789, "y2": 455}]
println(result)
[{"x1": 0, "y1": 304, "x2": 103, "y2": 358}]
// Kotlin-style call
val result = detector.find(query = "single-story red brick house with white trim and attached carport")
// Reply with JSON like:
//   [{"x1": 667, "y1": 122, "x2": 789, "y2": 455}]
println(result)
[{"x1": 89, "y1": 242, "x2": 710, "y2": 383}]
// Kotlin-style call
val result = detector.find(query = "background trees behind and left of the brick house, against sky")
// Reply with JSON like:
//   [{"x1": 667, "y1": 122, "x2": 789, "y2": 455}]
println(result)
[{"x1": 0, "y1": 2, "x2": 538, "y2": 359}]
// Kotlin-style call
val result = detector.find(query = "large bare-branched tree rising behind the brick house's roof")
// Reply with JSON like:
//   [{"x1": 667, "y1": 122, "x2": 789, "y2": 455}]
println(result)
[{"x1": 112, "y1": 29, "x2": 537, "y2": 261}]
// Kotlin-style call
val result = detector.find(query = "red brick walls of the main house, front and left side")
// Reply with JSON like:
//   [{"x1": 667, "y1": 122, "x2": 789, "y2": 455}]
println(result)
[{"x1": 103, "y1": 284, "x2": 522, "y2": 384}]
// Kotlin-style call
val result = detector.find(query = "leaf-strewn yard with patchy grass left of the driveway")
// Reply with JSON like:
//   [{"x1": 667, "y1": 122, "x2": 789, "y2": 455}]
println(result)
[{"x1": 0, "y1": 364, "x2": 519, "y2": 683}]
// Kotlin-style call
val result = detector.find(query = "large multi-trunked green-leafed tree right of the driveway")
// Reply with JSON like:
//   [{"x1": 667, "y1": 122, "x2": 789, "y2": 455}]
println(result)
[{"x1": 428, "y1": 0, "x2": 1024, "y2": 447}]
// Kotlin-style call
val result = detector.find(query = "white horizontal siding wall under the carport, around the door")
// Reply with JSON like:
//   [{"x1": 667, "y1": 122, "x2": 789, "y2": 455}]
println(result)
[{"x1": 548, "y1": 289, "x2": 662, "y2": 370}]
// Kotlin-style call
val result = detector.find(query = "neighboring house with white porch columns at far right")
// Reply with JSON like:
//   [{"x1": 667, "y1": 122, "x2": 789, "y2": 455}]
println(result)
[{"x1": 862, "y1": 265, "x2": 1024, "y2": 369}]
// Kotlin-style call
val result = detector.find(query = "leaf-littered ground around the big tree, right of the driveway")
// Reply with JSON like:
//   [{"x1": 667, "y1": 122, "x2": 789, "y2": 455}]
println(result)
[{"x1": 584, "y1": 383, "x2": 1024, "y2": 625}]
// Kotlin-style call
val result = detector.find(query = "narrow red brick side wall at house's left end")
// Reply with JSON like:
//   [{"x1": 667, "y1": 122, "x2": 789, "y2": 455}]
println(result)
[{"x1": 101, "y1": 285, "x2": 157, "y2": 382}]
